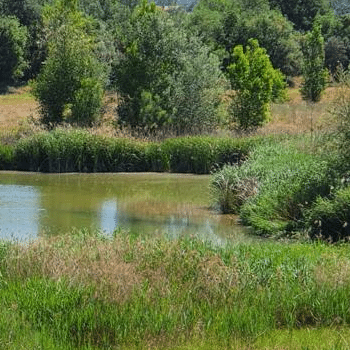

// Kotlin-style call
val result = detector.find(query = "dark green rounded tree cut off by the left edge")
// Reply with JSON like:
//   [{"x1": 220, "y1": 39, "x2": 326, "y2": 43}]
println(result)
[{"x1": 0, "y1": 16, "x2": 28, "y2": 83}]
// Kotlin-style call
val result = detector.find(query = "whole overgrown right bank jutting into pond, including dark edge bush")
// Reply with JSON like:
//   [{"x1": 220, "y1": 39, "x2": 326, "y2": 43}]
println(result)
[{"x1": 211, "y1": 134, "x2": 349, "y2": 240}]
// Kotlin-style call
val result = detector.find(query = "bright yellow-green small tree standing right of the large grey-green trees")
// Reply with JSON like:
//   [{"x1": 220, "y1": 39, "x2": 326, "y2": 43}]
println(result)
[{"x1": 227, "y1": 40, "x2": 285, "y2": 130}]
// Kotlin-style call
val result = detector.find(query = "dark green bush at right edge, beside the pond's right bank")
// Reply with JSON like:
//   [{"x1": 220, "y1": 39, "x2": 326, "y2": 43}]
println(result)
[{"x1": 306, "y1": 187, "x2": 350, "y2": 241}]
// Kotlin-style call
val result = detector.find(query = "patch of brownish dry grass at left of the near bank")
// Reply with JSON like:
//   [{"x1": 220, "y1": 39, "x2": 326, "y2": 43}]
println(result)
[{"x1": 6, "y1": 235, "x2": 143, "y2": 301}]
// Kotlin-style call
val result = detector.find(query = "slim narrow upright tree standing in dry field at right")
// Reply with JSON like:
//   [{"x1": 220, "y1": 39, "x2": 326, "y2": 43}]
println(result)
[{"x1": 301, "y1": 23, "x2": 328, "y2": 102}]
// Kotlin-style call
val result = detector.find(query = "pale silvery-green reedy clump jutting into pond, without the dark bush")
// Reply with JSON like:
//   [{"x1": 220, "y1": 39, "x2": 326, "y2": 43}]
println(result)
[{"x1": 212, "y1": 136, "x2": 336, "y2": 235}]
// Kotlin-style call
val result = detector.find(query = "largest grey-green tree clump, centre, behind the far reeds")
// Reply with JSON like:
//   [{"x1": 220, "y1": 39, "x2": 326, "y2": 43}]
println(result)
[{"x1": 113, "y1": 3, "x2": 226, "y2": 134}]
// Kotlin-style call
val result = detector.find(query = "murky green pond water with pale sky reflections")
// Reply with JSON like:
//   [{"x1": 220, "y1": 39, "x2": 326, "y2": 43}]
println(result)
[{"x1": 0, "y1": 172, "x2": 243, "y2": 243}]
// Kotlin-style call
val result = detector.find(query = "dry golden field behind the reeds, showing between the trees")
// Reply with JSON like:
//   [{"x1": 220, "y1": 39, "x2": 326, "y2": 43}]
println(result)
[{"x1": 0, "y1": 78, "x2": 342, "y2": 143}]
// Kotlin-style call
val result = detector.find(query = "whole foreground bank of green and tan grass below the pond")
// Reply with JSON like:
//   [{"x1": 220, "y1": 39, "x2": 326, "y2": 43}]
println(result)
[{"x1": 0, "y1": 232, "x2": 350, "y2": 349}]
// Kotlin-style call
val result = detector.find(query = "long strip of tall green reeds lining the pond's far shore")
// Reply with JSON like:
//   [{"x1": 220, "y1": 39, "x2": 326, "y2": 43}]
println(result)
[{"x1": 0, "y1": 129, "x2": 263, "y2": 174}]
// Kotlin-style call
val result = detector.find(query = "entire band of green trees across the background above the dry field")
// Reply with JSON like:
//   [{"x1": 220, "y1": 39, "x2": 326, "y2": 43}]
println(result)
[{"x1": 0, "y1": 0, "x2": 350, "y2": 134}]
